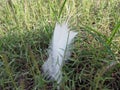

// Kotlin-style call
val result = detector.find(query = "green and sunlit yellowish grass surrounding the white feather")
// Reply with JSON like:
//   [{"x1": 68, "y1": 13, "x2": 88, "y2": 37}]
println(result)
[{"x1": 0, "y1": 0, "x2": 120, "y2": 90}]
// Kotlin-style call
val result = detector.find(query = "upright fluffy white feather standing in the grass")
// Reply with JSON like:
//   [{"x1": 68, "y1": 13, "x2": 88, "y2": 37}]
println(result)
[{"x1": 42, "y1": 23, "x2": 77, "y2": 84}]
